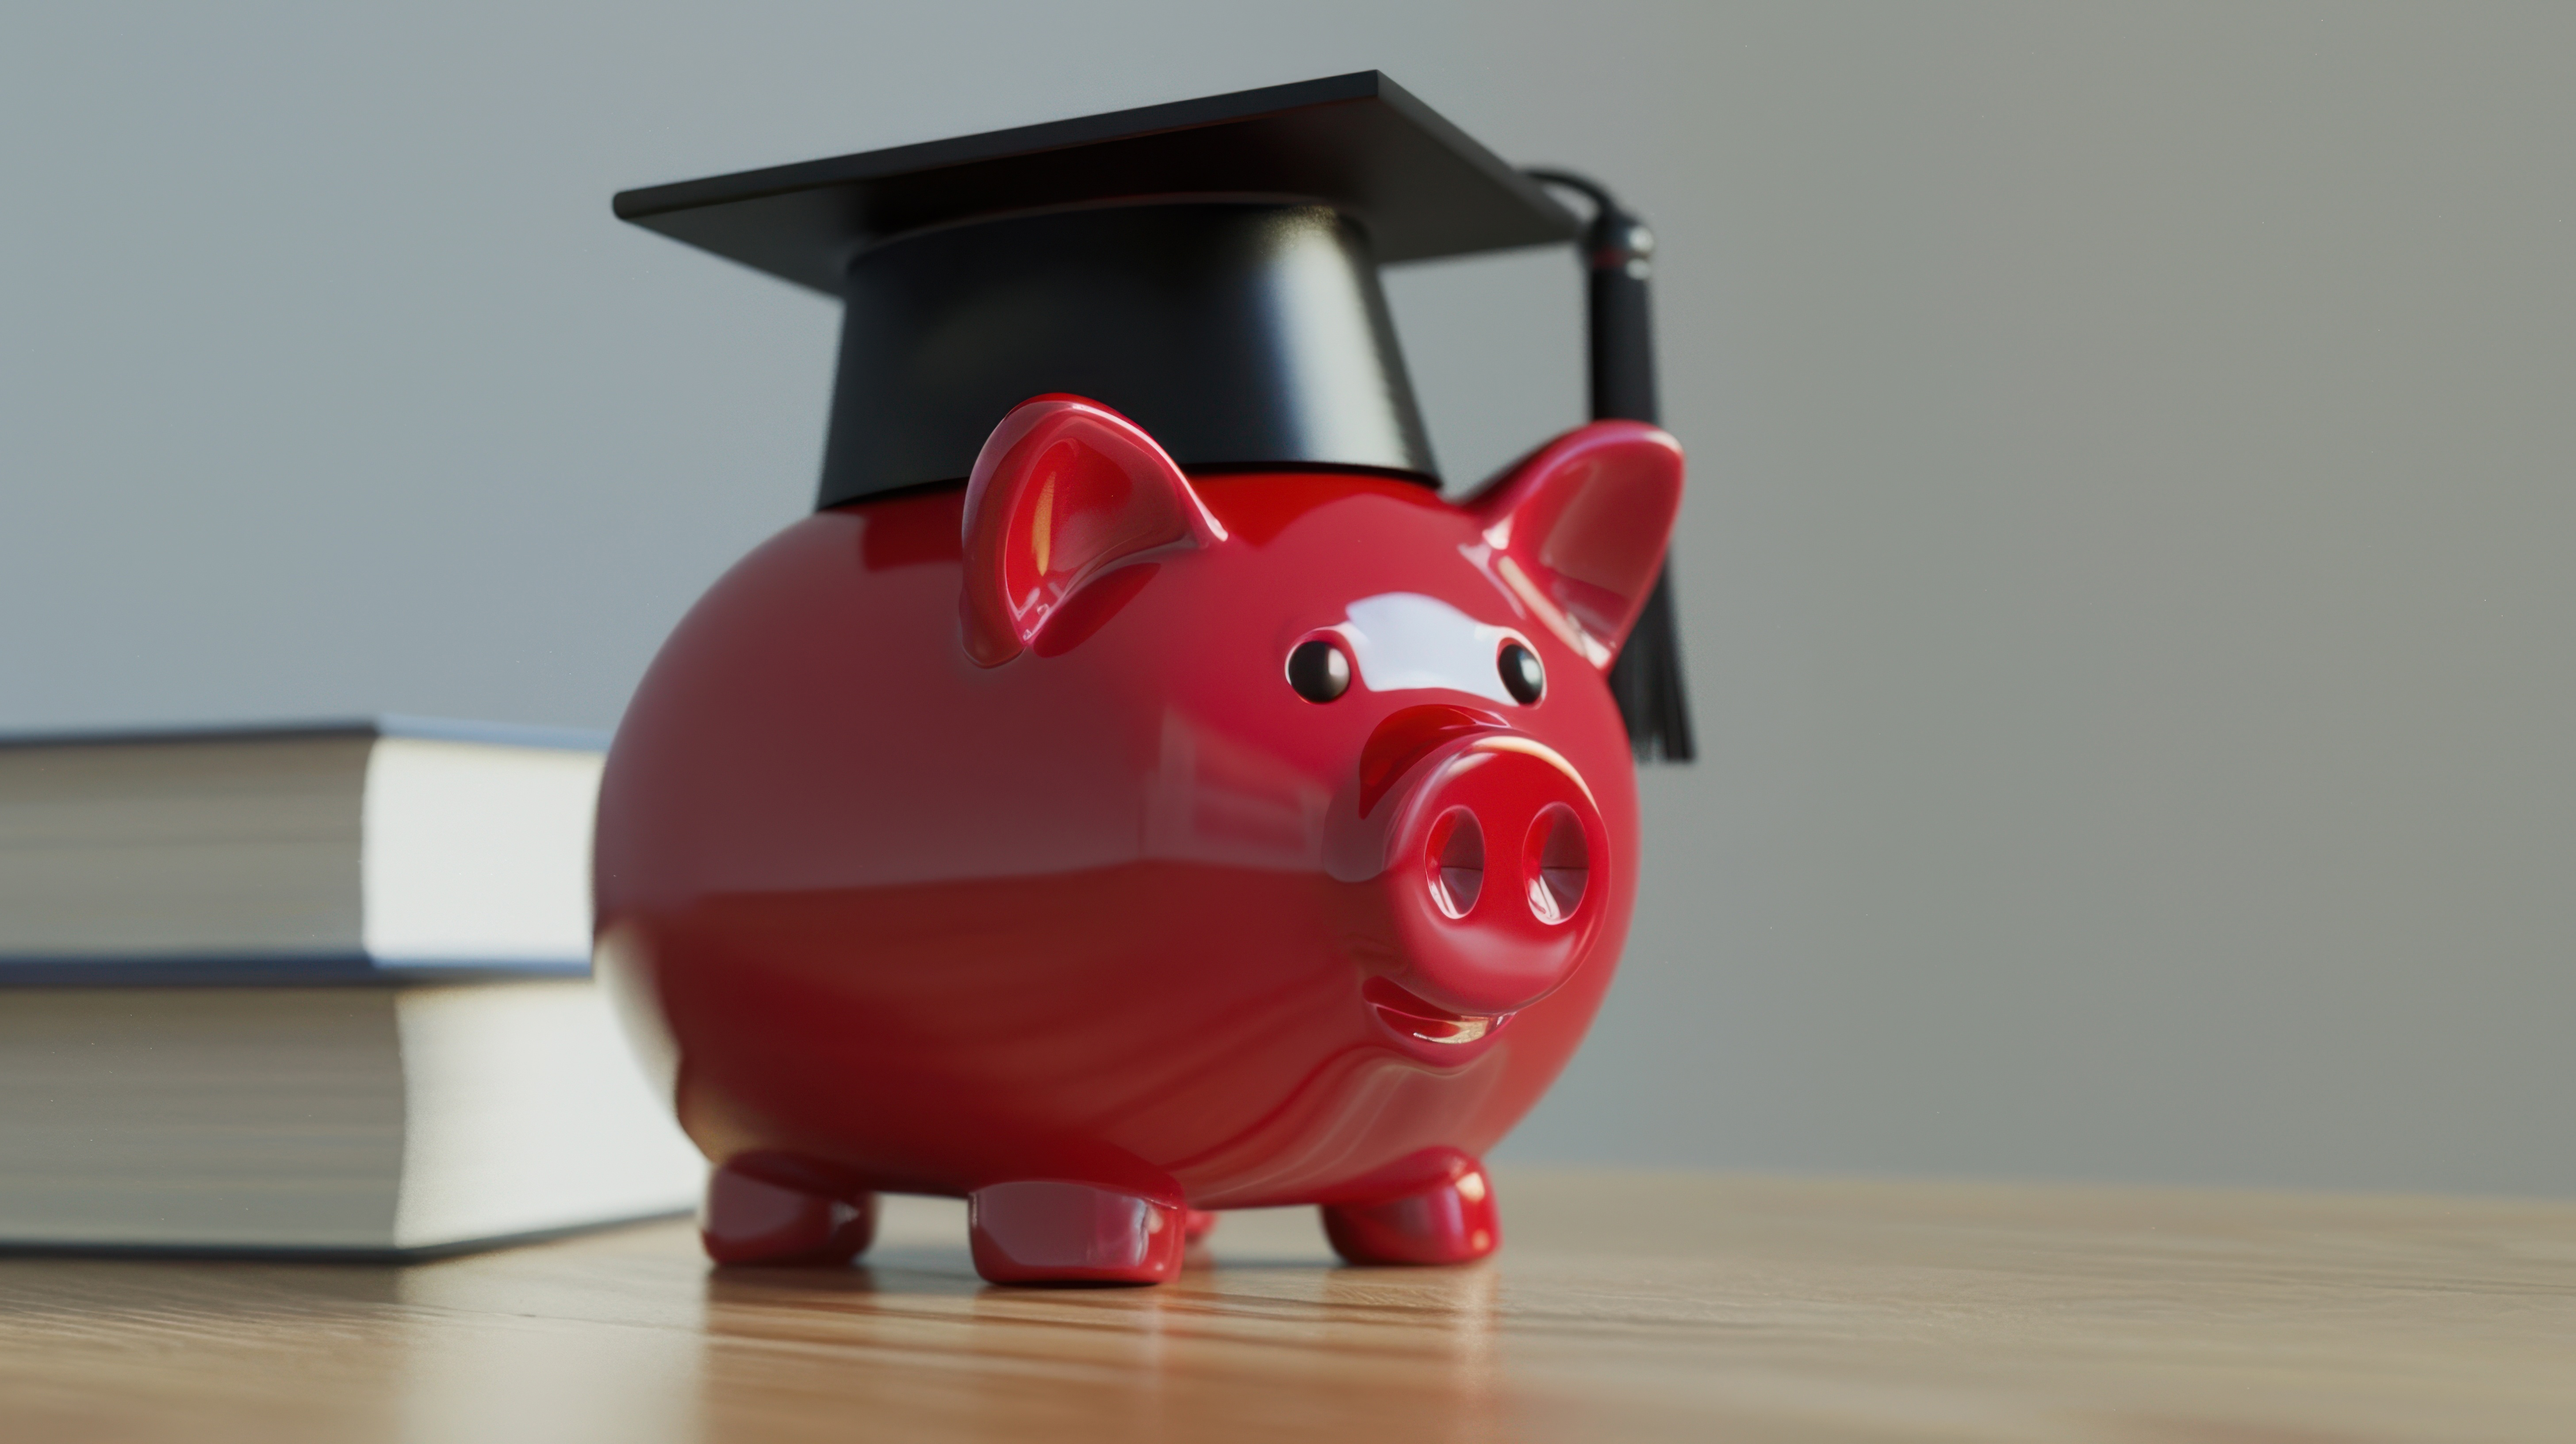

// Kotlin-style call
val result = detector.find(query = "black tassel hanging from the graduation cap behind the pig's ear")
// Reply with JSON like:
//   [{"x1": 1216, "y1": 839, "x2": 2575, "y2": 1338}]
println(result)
[{"x1": 1530, "y1": 170, "x2": 1698, "y2": 763}]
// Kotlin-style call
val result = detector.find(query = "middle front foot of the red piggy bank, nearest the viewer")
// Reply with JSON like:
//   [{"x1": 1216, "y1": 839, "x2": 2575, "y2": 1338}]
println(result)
[{"x1": 966, "y1": 1181, "x2": 1190, "y2": 1284}]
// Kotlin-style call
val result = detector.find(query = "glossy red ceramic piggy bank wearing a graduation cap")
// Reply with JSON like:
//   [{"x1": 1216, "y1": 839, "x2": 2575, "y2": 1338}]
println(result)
[{"x1": 598, "y1": 397, "x2": 1682, "y2": 1282}]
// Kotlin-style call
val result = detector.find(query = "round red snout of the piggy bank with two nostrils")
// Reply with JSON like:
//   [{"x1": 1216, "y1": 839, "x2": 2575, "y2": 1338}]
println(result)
[{"x1": 1381, "y1": 732, "x2": 1607, "y2": 1016}]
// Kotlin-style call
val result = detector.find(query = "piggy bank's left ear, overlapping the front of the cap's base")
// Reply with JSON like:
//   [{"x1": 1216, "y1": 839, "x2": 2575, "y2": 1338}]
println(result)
[{"x1": 958, "y1": 397, "x2": 1226, "y2": 668}]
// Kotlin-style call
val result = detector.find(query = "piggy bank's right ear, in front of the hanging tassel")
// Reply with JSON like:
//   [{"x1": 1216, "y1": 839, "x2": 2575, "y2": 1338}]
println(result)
[{"x1": 1468, "y1": 420, "x2": 1682, "y2": 668}]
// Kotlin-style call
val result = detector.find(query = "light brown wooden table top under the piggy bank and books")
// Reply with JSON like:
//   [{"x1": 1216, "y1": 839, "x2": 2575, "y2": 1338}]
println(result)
[{"x1": 0, "y1": 1171, "x2": 2576, "y2": 1444}]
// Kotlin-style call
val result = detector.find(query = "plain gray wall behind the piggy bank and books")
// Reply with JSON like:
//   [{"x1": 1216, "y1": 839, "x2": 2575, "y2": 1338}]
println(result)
[{"x1": 0, "y1": 0, "x2": 2576, "y2": 1194}]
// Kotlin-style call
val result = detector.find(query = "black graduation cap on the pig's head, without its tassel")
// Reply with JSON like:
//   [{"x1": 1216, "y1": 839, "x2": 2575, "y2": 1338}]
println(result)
[{"x1": 616, "y1": 69, "x2": 1582, "y2": 505}]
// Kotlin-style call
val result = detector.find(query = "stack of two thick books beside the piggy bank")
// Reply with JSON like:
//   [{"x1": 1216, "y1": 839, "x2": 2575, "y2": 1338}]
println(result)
[{"x1": 0, "y1": 719, "x2": 703, "y2": 1256}]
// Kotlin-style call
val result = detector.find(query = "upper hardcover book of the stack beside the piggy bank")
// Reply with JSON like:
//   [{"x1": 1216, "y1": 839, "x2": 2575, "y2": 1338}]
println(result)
[{"x1": 0, "y1": 717, "x2": 608, "y2": 985}]
